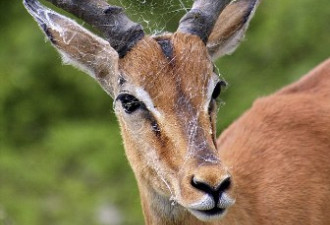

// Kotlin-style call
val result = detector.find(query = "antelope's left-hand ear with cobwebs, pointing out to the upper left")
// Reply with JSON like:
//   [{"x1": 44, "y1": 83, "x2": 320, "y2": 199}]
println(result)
[{"x1": 24, "y1": 0, "x2": 119, "y2": 96}]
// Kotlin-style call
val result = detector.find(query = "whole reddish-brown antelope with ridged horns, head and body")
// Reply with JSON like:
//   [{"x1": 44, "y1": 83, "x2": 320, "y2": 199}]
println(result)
[{"x1": 24, "y1": 0, "x2": 330, "y2": 225}]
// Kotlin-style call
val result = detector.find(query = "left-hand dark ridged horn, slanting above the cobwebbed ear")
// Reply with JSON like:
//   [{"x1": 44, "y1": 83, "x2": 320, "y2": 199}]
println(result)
[{"x1": 47, "y1": 0, "x2": 144, "y2": 58}]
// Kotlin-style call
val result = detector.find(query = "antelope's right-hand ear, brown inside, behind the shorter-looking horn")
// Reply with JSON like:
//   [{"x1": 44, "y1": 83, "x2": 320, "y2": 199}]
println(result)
[{"x1": 207, "y1": 0, "x2": 260, "y2": 60}]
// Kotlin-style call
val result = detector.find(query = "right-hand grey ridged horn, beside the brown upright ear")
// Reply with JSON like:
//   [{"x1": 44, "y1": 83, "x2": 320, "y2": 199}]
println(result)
[{"x1": 178, "y1": 0, "x2": 231, "y2": 43}]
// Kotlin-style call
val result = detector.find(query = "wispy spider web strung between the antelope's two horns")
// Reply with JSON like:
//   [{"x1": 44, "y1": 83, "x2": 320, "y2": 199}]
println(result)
[{"x1": 113, "y1": 0, "x2": 193, "y2": 34}]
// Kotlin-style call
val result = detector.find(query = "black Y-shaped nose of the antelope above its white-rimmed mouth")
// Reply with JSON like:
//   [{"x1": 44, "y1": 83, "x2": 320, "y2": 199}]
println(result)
[{"x1": 191, "y1": 177, "x2": 231, "y2": 202}]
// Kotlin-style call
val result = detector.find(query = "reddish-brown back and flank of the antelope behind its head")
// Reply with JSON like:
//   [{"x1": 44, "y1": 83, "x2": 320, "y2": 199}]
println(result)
[{"x1": 218, "y1": 60, "x2": 330, "y2": 225}]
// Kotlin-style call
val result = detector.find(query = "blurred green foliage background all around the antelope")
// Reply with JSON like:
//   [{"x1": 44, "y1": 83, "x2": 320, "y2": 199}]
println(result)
[{"x1": 0, "y1": 0, "x2": 330, "y2": 225}]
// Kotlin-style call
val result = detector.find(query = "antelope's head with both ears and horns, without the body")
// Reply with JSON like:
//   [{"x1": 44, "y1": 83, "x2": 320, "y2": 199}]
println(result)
[{"x1": 24, "y1": 0, "x2": 258, "y2": 220}]
